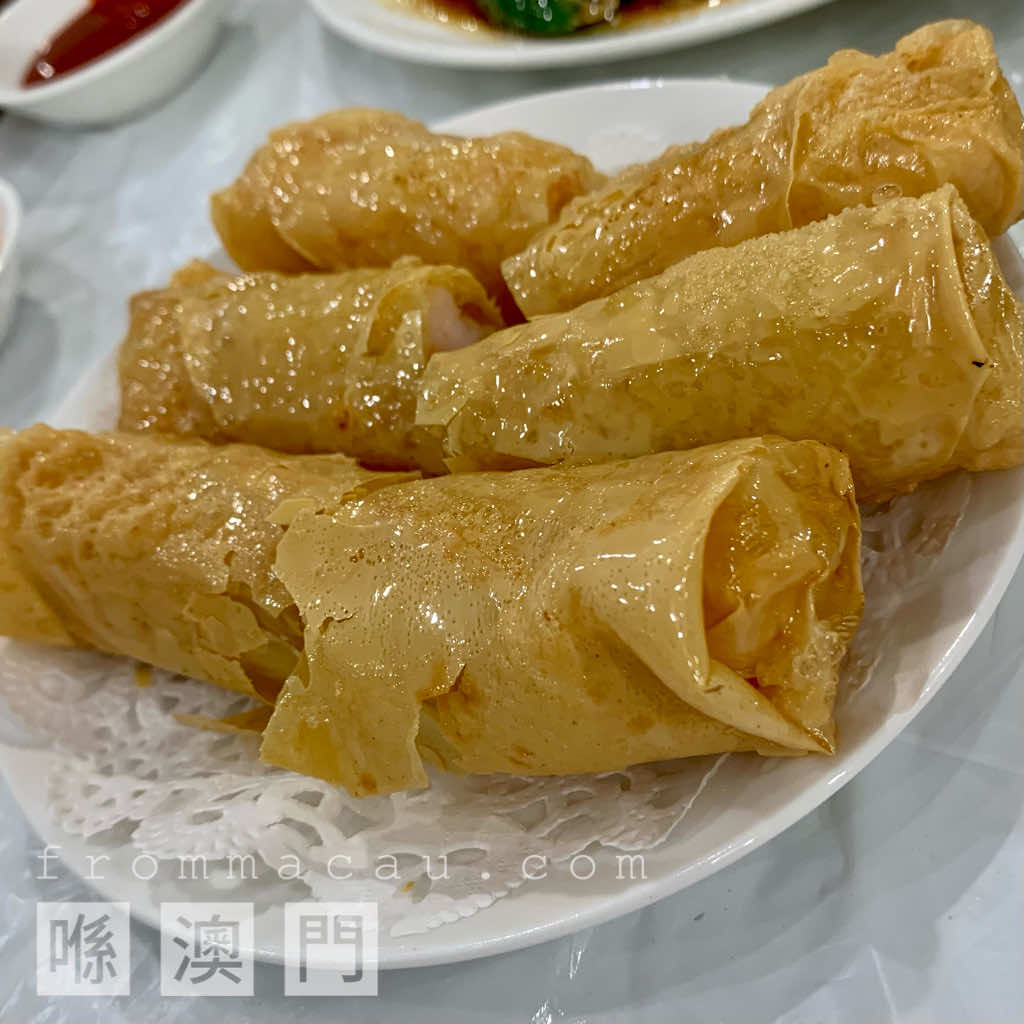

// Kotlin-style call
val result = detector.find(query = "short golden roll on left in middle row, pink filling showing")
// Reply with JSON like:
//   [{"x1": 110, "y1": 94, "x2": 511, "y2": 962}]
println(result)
[{"x1": 119, "y1": 260, "x2": 502, "y2": 470}]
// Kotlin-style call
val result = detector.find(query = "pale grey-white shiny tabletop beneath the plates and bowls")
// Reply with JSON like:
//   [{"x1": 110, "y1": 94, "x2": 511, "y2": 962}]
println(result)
[{"x1": 0, "y1": 0, "x2": 1024, "y2": 1024}]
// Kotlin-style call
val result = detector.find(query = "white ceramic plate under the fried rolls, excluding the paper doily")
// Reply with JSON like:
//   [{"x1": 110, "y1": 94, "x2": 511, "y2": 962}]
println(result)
[{"x1": 6, "y1": 80, "x2": 1024, "y2": 968}]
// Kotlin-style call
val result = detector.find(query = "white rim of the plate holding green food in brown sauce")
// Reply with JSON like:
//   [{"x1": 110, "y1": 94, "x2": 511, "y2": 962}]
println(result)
[{"x1": 309, "y1": 0, "x2": 834, "y2": 71}]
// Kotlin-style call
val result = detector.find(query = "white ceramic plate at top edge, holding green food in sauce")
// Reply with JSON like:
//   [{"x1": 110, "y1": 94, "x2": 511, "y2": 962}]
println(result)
[{"x1": 310, "y1": 0, "x2": 830, "y2": 69}]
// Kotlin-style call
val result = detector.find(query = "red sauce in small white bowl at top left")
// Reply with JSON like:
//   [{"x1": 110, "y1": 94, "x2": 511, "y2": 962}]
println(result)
[{"x1": 22, "y1": 0, "x2": 193, "y2": 86}]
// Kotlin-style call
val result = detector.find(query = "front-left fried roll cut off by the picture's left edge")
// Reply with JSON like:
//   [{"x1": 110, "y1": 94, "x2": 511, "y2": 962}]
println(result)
[{"x1": 0, "y1": 426, "x2": 412, "y2": 701}]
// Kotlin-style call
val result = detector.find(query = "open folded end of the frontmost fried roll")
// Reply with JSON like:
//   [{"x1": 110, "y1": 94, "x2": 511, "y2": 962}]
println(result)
[{"x1": 702, "y1": 450, "x2": 860, "y2": 753}]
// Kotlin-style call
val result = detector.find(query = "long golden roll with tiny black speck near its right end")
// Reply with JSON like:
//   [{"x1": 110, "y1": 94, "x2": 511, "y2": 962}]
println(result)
[{"x1": 418, "y1": 186, "x2": 1022, "y2": 500}]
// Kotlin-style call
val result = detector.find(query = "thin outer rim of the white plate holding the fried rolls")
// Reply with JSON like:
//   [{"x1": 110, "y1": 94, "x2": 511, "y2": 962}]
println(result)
[{"x1": 0, "y1": 77, "x2": 1024, "y2": 971}]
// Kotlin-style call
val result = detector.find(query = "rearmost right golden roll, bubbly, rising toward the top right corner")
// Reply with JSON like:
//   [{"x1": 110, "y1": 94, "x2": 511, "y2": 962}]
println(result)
[{"x1": 504, "y1": 20, "x2": 1021, "y2": 316}]
